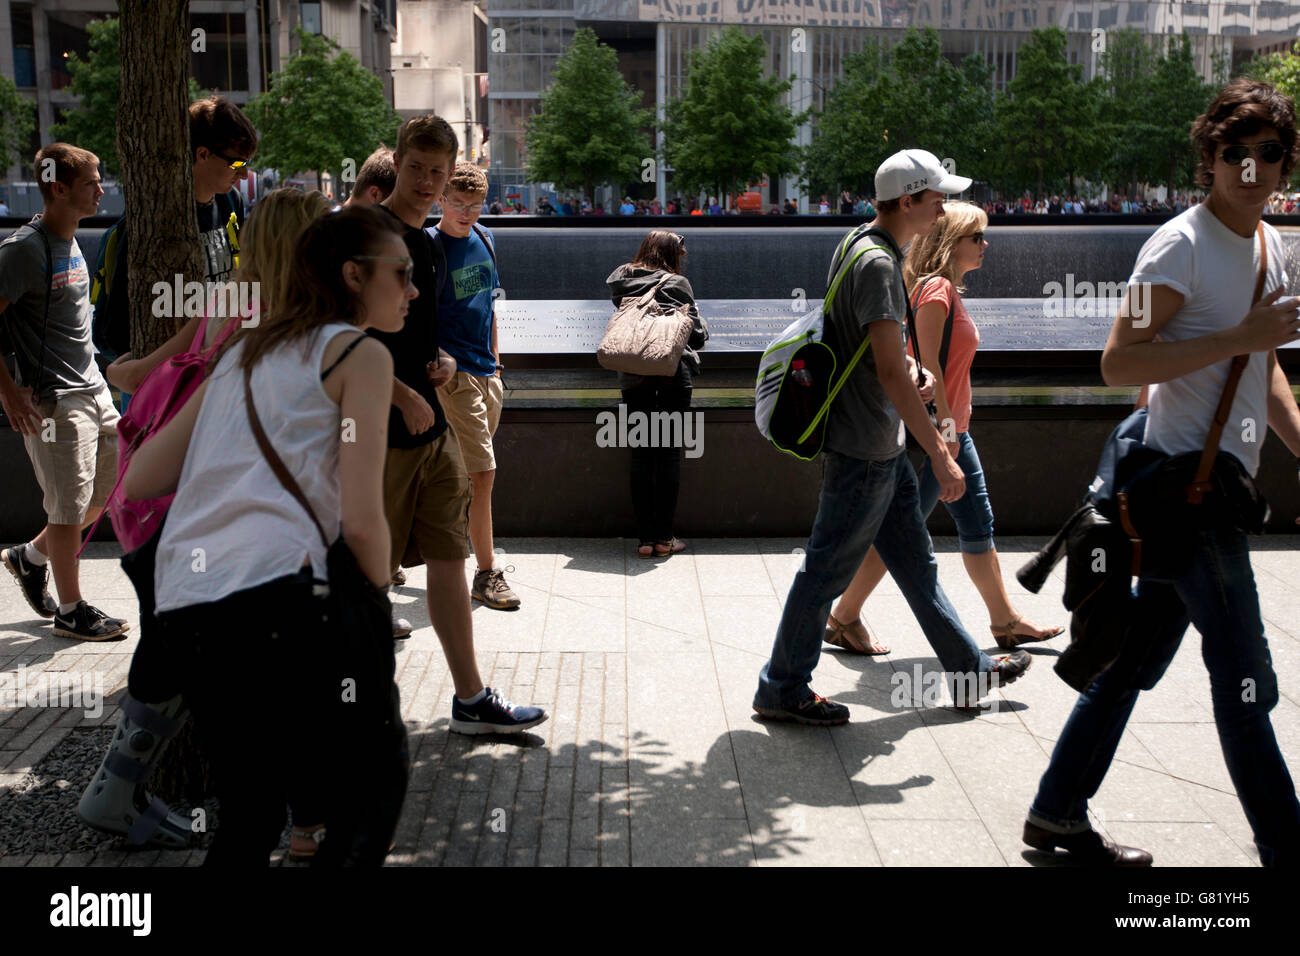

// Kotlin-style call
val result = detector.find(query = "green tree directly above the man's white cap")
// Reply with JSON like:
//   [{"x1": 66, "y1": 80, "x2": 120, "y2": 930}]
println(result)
[{"x1": 805, "y1": 27, "x2": 995, "y2": 199}]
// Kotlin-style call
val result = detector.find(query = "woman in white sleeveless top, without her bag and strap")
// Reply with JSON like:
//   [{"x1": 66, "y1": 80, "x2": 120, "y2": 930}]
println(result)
[{"x1": 124, "y1": 208, "x2": 416, "y2": 865}]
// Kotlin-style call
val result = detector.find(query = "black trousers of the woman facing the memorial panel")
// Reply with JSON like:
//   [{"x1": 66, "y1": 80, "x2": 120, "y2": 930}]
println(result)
[{"x1": 623, "y1": 375, "x2": 690, "y2": 544}]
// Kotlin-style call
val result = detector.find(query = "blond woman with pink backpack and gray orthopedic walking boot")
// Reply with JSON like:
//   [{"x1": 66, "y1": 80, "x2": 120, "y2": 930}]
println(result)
[{"x1": 78, "y1": 189, "x2": 330, "y2": 848}]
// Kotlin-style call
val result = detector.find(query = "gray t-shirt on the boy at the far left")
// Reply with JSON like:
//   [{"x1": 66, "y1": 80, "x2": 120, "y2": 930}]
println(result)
[{"x1": 0, "y1": 226, "x2": 104, "y2": 399}]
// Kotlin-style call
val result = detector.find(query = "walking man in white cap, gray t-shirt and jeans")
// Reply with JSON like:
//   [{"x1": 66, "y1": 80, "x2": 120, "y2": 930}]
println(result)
[{"x1": 754, "y1": 150, "x2": 1030, "y2": 724}]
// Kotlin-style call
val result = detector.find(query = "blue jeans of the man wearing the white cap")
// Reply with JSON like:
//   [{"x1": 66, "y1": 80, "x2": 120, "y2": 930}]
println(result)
[{"x1": 754, "y1": 451, "x2": 993, "y2": 708}]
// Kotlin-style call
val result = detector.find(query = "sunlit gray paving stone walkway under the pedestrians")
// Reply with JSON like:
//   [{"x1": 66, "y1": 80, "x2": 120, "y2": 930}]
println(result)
[{"x1": 0, "y1": 537, "x2": 1300, "y2": 866}]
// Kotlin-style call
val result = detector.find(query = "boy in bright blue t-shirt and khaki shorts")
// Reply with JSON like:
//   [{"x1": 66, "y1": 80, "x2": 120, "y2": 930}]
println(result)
[{"x1": 429, "y1": 163, "x2": 519, "y2": 610}]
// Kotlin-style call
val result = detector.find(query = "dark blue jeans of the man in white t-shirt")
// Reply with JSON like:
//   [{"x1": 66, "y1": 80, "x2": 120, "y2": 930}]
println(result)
[{"x1": 1030, "y1": 531, "x2": 1300, "y2": 866}]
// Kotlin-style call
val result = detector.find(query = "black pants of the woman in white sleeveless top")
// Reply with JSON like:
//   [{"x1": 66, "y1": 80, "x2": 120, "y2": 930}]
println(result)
[{"x1": 159, "y1": 575, "x2": 347, "y2": 866}]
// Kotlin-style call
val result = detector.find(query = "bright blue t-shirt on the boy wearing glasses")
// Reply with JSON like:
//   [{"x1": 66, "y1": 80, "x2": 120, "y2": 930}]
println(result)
[{"x1": 429, "y1": 226, "x2": 501, "y2": 377}]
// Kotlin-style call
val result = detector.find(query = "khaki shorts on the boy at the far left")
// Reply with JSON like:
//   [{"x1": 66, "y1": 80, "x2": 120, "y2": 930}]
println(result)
[{"x1": 22, "y1": 385, "x2": 121, "y2": 525}]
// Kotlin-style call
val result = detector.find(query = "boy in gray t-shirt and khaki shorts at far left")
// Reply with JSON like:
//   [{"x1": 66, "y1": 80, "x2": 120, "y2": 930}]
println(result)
[{"x1": 0, "y1": 143, "x2": 130, "y2": 641}]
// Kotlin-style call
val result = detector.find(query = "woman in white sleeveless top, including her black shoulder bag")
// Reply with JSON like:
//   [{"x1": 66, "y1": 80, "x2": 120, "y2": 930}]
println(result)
[{"x1": 124, "y1": 207, "x2": 416, "y2": 866}]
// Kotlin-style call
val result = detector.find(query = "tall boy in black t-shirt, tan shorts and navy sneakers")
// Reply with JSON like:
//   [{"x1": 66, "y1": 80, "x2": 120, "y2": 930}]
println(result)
[{"x1": 371, "y1": 113, "x2": 547, "y2": 734}]
